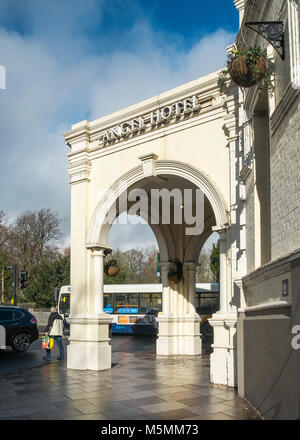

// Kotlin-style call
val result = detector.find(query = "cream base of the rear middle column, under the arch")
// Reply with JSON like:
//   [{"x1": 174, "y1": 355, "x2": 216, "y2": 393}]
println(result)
[{"x1": 156, "y1": 315, "x2": 202, "y2": 356}]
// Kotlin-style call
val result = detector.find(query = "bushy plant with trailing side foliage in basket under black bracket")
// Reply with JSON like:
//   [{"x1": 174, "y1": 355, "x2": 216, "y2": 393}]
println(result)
[{"x1": 219, "y1": 46, "x2": 274, "y2": 94}]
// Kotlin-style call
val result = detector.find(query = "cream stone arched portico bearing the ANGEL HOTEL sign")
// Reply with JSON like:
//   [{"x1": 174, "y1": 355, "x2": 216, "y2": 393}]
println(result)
[{"x1": 65, "y1": 74, "x2": 239, "y2": 385}]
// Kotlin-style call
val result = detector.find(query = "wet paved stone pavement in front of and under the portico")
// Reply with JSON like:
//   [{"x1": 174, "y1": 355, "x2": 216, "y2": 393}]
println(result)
[{"x1": 0, "y1": 335, "x2": 260, "y2": 420}]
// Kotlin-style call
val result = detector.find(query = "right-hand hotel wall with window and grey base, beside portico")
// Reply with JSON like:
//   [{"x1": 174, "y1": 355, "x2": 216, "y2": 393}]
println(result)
[{"x1": 235, "y1": 0, "x2": 300, "y2": 419}]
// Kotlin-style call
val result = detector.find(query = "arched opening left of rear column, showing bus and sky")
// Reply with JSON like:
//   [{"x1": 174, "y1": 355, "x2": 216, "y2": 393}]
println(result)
[{"x1": 104, "y1": 212, "x2": 162, "y2": 356}]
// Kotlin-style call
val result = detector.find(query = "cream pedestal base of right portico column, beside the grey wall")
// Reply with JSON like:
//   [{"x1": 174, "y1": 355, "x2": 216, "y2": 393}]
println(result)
[{"x1": 209, "y1": 312, "x2": 237, "y2": 387}]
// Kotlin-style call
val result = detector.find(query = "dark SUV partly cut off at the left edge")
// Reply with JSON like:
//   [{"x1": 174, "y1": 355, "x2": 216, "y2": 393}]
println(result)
[{"x1": 0, "y1": 306, "x2": 39, "y2": 352}]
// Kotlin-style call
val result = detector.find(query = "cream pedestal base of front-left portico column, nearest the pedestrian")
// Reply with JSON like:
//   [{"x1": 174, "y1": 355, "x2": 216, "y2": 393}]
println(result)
[{"x1": 67, "y1": 313, "x2": 112, "y2": 371}]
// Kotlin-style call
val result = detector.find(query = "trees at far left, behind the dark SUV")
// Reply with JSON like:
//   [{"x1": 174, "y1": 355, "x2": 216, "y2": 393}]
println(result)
[{"x1": 0, "y1": 208, "x2": 65, "y2": 307}]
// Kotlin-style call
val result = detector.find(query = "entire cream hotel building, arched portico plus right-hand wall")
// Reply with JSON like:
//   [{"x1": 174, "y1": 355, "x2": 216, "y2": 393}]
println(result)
[{"x1": 65, "y1": 0, "x2": 300, "y2": 418}]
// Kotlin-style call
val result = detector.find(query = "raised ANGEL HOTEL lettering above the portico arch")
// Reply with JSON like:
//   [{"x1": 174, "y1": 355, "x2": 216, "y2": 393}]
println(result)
[{"x1": 99, "y1": 95, "x2": 201, "y2": 145}]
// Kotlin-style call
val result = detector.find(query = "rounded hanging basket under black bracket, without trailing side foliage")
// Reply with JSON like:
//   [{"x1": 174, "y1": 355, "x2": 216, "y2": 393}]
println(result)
[{"x1": 227, "y1": 55, "x2": 268, "y2": 87}]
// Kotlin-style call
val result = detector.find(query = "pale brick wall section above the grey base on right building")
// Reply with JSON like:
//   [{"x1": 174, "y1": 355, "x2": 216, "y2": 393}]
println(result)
[{"x1": 270, "y1": 94, "x2": 300, "y2": 260}]
